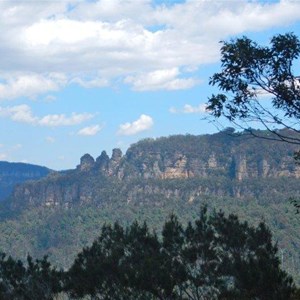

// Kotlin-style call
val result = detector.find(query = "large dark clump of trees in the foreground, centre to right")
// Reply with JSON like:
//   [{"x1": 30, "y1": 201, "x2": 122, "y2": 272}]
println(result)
[{"x1": 65, "y1": 208, "x2": 294, "y2": 300}]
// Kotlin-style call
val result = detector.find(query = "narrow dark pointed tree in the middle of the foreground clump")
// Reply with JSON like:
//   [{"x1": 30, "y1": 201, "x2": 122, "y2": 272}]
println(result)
[{"x1": 183, "y1": 207, "x2": 226, "y2": 300}]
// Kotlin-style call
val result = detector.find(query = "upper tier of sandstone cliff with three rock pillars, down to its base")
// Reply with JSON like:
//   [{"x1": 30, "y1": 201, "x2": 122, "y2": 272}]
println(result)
[{"x1": 71, "y1": 134, "x2": 300, "y2": 181}]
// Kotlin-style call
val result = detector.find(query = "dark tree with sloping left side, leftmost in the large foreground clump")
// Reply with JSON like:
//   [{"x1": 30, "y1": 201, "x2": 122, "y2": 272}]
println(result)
[{"x1": 65, "y1": 223, "x2": 126, "y2": 300}]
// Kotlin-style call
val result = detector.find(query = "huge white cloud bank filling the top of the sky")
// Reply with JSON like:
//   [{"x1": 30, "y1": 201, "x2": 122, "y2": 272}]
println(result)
[{"x1": 0, "y1": 0, "x2": 300, "y2": 95}]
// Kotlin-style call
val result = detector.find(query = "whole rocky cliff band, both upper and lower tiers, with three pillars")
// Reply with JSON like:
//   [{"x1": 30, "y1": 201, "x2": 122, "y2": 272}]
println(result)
[{"x1": 11, "y1": 133, "x2": 300, "y2": 208}]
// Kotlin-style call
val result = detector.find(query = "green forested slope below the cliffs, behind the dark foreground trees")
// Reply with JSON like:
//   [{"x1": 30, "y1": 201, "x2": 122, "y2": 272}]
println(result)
[{"x1": 0, "y1": 177, "x2": 300, "y2": 282}]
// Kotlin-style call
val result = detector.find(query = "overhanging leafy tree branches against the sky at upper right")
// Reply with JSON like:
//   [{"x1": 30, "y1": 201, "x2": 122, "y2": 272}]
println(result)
[{"x1": 207, "y1": 33, "x2": 300, "y2": 147}]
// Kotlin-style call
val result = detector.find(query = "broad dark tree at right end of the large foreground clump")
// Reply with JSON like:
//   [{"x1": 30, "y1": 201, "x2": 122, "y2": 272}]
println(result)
[{"x1": 211, "y1": 212, "x2": 294, "y2": 300}]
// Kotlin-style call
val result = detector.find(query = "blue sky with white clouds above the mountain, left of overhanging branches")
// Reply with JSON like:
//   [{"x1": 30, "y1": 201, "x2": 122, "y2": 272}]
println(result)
[{"x1": 0, "y1": 0, "x2": 300, "y2": 170}]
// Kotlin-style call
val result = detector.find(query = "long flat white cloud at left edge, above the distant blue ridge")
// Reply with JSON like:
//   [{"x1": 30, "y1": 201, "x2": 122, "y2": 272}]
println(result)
[{"x1": 0, "y1": 104, "x2": 94, "y2": 127}]
